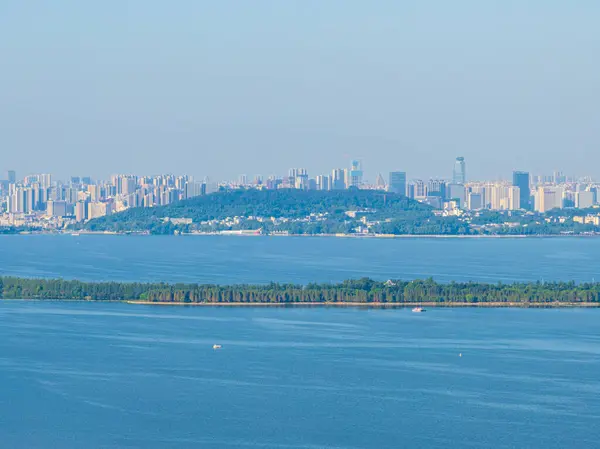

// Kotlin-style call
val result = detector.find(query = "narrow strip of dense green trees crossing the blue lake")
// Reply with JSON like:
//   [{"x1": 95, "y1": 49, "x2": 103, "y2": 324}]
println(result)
[{"x1": 0, "y1": 277, "x2": 600, "y2": 305}]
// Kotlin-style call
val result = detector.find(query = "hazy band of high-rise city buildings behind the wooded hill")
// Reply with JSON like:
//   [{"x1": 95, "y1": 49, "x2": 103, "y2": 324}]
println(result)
[{"x1": 0, "y1": 156, "x2": 600, "y2": 227}]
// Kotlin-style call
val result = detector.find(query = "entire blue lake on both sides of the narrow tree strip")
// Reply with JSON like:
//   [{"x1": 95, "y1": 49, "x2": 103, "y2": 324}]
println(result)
[{"x1": 0, "y1": 236, "x2": 600, "y2": 449}]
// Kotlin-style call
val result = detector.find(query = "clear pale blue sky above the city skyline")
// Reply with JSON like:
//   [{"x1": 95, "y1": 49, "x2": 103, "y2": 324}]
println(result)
[{"x1": 0, "y1": 0, "x2": 600, "y2": 181}]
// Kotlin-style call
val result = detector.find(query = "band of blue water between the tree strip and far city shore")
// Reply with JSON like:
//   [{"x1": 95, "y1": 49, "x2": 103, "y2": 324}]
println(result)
[{"x1": 0, "y1": 235, "x2": 600, "y2": 283}]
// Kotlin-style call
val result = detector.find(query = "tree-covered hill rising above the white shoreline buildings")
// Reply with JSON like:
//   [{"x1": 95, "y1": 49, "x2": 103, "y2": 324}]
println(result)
[{"x1": 79, "y1": 189, "x2": 432, "y2": 234}]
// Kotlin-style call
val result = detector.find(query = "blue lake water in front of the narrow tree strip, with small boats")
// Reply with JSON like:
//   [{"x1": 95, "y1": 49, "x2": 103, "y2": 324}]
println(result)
[{"x1": 0, "y1": 302, "x2": 600, "y2": 449}]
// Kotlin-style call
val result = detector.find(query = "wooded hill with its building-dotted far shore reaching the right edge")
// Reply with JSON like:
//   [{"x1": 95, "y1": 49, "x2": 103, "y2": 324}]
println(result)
[{"x1": 71, "y1": 189, "x2": 600, "y2": 236}]
